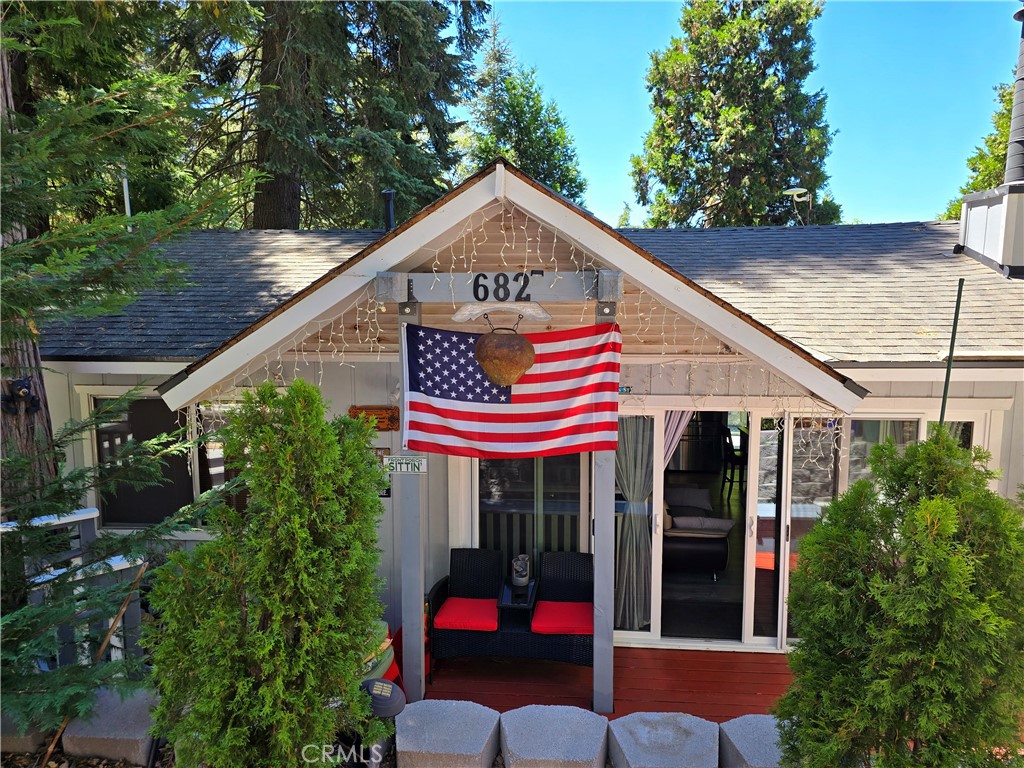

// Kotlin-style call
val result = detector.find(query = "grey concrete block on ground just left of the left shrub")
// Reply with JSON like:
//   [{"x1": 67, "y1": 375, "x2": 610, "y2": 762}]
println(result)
[{"x1": 62, "y1": 688, "x2": 157, "y2": 765}]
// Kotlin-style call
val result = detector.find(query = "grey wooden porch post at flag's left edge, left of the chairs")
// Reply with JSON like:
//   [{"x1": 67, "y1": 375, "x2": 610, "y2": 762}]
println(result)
[{"x1": 392, "y1": 309, "x2": 426, "y2": 701}]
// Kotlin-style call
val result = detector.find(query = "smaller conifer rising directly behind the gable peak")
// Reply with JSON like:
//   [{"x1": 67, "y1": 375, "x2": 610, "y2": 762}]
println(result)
[{"x1": 465, "y1": 19, "x2": 587, "y2": 205}]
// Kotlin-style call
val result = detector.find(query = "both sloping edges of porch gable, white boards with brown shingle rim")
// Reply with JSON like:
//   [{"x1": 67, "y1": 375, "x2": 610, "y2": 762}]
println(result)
[{"x1": 149, "y1": 160, "x2": 866, "y2": 411}]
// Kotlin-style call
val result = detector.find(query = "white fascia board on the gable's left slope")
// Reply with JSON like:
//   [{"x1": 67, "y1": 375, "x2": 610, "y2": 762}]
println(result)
[{"x1": 163, "y1": 174, "x2": 503, "y2": 411}]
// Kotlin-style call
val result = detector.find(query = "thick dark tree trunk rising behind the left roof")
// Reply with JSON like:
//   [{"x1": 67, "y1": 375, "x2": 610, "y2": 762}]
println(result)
[{"x1": 253, "y1": 2, "x2": 302, "y2": 229}]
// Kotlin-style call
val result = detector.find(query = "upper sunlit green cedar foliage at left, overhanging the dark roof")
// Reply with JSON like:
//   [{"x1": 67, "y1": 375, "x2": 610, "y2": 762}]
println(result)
[{"x1": 0, "y1": 3, "x2": 252, "y2": 347}]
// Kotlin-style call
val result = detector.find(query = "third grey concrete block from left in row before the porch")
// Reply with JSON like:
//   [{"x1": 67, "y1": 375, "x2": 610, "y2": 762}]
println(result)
[{"x1": 608, "y1": 712, "x2": 718, "y2": 768}]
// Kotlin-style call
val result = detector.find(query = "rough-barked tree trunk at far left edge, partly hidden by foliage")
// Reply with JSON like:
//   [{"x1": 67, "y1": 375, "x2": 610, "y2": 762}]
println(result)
[{"x1": 0, "y1": 51, "x2": 56, "y2": 517}]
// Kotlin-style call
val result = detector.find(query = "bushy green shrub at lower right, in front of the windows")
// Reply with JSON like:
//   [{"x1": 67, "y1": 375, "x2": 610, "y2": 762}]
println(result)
[{"x1": 776, "y1": 428, "x2": 1024, "y2": 768}]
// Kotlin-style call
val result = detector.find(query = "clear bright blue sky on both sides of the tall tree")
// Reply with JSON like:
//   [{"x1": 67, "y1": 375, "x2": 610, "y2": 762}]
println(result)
[{"x1": 494, "y1": 0, "x2": 1021, "y2": 224}]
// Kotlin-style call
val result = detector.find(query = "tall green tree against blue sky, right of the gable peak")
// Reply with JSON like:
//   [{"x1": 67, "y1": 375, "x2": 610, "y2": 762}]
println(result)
[{"x1": 632, "y1": 0, "x2": 840, "y2": 226}]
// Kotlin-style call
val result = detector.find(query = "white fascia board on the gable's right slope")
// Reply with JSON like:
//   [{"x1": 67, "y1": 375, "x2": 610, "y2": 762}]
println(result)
[{"x1": 505, "y1": 174, "x2": 862, "y2": 413}]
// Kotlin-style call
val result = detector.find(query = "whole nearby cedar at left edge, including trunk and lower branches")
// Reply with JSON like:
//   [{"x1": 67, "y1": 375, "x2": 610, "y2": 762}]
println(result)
[{"x1": 0, "y1": 2, "x2": 249, "y2": 728}]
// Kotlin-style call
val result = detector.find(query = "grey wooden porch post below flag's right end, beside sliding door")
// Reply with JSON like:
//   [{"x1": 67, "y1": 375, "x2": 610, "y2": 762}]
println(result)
[{"x1": 594, "y1": 451, "x2": 615, "y2": 714}]
